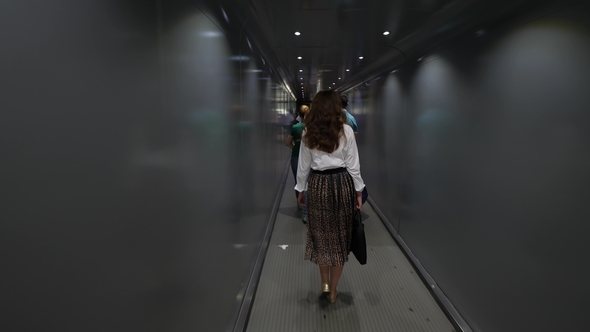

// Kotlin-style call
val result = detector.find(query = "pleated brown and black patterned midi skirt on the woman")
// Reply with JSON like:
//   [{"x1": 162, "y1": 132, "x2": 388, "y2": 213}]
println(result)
[{"x1": 305, "y1": 168, "x2": 356, "y2": 266}]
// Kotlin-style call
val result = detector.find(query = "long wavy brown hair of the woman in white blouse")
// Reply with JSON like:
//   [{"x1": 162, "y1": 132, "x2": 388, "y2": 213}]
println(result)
[{"x1": 303, "y1": 90, "x2": 346, "y2": 153}]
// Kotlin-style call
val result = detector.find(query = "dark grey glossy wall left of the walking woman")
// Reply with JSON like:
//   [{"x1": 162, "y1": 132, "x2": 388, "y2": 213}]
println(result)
[{"x1": 0, "y1": 0, "x2": 295, "y2": 331}]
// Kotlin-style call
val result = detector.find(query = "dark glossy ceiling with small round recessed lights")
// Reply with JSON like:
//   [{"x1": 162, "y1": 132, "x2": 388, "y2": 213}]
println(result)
[{"x1": 231, "y1": 0, "x2": 531, "y2": 100}]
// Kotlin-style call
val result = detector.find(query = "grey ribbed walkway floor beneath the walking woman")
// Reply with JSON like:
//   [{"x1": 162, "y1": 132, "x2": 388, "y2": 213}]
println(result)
[{"x1": 246, "y1": 176, "x2": 455, "y2": 332}]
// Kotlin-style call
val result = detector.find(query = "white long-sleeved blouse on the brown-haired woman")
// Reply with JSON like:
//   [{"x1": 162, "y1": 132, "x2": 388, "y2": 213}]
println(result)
[{"x1": 295, "y1": 124, "x2": 365, "y2": 191}]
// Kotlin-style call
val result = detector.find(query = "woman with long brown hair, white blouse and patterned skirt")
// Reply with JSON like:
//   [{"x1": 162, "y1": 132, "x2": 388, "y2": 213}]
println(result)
[{"x1": 295, "y1": 90, "x2": 365, "y2": 303}]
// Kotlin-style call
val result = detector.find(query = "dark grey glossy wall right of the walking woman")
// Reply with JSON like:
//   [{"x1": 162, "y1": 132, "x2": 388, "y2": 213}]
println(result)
[{"x1": 347, "y1": 2, "x2": 590, "y2": 331}]
